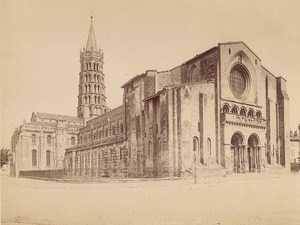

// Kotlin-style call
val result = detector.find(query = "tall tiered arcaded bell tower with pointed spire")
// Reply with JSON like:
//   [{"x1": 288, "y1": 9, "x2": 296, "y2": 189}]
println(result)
[{"x1": 77, "y1": 16, "x2": 108, "y2": 120}]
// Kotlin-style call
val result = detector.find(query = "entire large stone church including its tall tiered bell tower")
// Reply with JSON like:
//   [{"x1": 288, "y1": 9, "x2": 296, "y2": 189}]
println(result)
[{"x1": 12, "y1": 20, "x2": 290, "y2": 178}]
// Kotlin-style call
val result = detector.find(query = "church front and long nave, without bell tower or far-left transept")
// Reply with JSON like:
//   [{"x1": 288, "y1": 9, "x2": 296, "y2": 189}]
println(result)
[{"x1": 66, "y1": 20, "x2": 289, "y2": 177}]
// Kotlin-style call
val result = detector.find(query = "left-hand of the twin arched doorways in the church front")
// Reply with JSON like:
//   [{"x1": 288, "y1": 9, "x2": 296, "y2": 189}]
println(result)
[{"x1": 231, "y1": 133, "x2": 245, "y2": 173}]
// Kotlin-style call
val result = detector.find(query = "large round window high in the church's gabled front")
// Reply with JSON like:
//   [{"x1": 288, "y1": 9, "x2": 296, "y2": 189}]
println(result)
[{"x1": 229, "y1": 65, "x2": 249, "y2": 98}]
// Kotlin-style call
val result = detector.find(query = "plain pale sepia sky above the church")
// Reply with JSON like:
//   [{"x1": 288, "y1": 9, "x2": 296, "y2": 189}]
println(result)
[{"x1": 0, "y1": 0, "x2": 300, "y2": 148}]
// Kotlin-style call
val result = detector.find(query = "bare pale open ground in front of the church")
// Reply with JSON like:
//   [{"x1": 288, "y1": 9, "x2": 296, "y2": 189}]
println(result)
[{"x1": 1, "y1": 174, "x2": 300, "y2": 225}]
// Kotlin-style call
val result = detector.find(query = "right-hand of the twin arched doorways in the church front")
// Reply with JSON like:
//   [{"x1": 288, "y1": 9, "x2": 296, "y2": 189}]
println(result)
[{"x1": 248, "y1": 134, "x2": 261, "y2": 173}]
